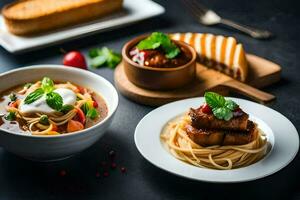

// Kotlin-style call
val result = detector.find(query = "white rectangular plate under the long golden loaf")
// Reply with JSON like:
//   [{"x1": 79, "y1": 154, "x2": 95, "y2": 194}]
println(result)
[{"x1": 0, "y1": 0, "x2": 165, "y2": 53}]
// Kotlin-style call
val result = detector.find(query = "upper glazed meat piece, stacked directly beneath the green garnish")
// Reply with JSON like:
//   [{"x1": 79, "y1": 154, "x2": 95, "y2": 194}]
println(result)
[{"x1": 189, "y1": 108, "x2": 249, "y2": 131}]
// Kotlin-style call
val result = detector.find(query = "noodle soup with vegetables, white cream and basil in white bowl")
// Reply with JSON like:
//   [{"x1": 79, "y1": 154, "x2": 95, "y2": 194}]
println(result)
[{"x1": 0, "y1": 77, "x2": 108, "y2": 135}]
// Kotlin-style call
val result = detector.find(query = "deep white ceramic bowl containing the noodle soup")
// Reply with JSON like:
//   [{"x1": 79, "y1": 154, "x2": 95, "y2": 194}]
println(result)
[{"x1": 0, "y1": 65, "x2": 119, "y2": 161}]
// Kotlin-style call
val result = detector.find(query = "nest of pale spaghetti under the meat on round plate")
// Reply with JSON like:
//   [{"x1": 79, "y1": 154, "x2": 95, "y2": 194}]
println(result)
[{"x1": 161, "y1": 114, "x2": 268, "y2": 170}]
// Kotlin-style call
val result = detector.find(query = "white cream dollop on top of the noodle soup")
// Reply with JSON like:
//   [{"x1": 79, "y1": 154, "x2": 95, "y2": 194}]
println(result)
[{"x1": 19, "y1": 88, "x2": 76, "y2": 114}]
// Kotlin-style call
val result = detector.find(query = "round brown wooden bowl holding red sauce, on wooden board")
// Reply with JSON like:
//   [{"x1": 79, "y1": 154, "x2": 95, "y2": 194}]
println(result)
[{"x1": 122, "y1": 35, "x2": 197, "y2": 90}]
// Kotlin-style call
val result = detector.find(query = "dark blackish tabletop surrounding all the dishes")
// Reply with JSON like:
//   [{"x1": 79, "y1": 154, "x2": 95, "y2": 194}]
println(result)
[{"x1": 0, "y1": 0, "x2": 300, "y2": 200}]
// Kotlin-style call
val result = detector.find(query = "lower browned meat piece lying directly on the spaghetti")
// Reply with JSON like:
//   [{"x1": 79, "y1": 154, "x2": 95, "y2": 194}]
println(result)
[{"x1": 185, "y1": 121, "x2": 258, "y2": 147}]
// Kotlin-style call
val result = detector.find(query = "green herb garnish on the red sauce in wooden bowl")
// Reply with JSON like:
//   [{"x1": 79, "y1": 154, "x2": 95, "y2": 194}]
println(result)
[{"x1": 137, "y1": 32, "x2": 180, "y2": 59}]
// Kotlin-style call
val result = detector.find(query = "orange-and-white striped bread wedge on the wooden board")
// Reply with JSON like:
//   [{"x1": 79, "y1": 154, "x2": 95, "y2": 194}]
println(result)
[{"x1": 171, "y1": 33, "x2": 248, "y2": 81}]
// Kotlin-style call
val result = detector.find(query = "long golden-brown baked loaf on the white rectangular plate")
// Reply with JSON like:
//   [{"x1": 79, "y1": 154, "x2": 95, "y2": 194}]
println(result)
[{"x1": 2, "y1": 0, "x2": 123, "y2": 35}]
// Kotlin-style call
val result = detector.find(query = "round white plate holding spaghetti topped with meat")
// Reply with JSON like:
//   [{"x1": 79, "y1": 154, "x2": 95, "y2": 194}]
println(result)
[{"x1": 134, "y1": 97, "x2": 299, "y2": 183}]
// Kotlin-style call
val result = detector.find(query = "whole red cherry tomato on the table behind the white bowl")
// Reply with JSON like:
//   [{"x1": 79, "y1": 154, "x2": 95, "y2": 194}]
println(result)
[{"x1": 63, "y1": 51, "x2": 87, "y2": 69}]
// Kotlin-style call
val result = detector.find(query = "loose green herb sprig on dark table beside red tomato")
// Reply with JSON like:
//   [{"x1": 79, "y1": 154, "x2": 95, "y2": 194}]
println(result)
[{"x1": 89, "y1": 47, "x2": 122, "y2": 69}]
